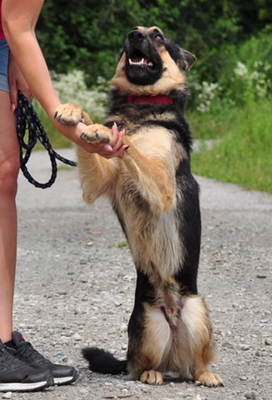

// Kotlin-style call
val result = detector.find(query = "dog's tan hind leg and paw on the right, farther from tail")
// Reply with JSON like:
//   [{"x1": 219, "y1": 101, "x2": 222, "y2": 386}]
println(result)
[{"x1": 182, "y1": 296, "x2": 223, "y2": 386}]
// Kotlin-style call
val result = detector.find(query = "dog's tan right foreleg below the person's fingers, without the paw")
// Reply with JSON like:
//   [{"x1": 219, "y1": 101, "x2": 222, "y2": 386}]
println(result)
[{"x1": 123, "y1": 142, "x2": 176, "y2": 213}]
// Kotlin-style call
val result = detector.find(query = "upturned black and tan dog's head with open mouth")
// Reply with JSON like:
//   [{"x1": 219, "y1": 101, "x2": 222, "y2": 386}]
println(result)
[{"x1": 112, "y1": 26, "x2": 196, "y2": 95}]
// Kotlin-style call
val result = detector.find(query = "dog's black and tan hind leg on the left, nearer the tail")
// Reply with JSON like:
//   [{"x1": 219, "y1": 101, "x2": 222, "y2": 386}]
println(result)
[{"x1": 127, "y1": 272, "x2": 171, "y2": 385}]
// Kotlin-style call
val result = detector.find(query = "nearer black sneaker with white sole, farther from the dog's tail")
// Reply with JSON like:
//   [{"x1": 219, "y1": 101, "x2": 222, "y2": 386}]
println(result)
[{"x1": 0, "y1": 340, "x2": 54, "y2": 392}]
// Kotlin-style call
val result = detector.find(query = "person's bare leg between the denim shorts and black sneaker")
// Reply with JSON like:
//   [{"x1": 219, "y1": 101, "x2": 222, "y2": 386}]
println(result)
[{"x1": 0, "y1": 91, "x2": 19, "y2": 342}]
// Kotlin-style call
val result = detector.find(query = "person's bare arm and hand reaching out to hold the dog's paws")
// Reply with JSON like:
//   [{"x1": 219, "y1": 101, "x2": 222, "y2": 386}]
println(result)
[{"x1": 2, "y1": 0, "x2": 125, "y2": 157}]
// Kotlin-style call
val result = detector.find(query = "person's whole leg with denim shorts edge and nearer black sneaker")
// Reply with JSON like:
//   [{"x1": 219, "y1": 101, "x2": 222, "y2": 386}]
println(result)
[{"x1": 0, "y1": 39, "x2": 54, "y2": 392}]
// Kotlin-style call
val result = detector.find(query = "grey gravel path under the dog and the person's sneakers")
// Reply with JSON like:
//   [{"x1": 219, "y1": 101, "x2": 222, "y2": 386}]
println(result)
[{"x1": 4, "y1": 150, "x2": 272, "y2": 400}]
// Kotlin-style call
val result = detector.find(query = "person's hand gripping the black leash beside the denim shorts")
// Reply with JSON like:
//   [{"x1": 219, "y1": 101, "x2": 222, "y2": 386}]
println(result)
[{"x1": 9, "y1": 54, "x2": 33, "y2": 112}]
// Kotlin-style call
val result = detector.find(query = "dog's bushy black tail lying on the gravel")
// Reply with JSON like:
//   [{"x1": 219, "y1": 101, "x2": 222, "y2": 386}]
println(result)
[{"x1": 82, "y1": 347, "x2": 127, "y2": 375}]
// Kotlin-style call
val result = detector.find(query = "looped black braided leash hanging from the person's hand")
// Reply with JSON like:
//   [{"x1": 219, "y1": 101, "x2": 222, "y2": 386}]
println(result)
[{"x1": 16, "y1": 92, "x2": 77, "y2": 189}]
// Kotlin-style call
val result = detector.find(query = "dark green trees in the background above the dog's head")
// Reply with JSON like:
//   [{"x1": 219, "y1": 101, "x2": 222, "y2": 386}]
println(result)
[{"x1": 37, "y1": 0, "x2": 272, "y2": 85}]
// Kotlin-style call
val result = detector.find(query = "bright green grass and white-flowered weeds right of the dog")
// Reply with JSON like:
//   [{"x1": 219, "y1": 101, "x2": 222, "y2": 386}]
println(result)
[{"x1": 188, "y1": 33, "x2": 272, "y2": 193}]
